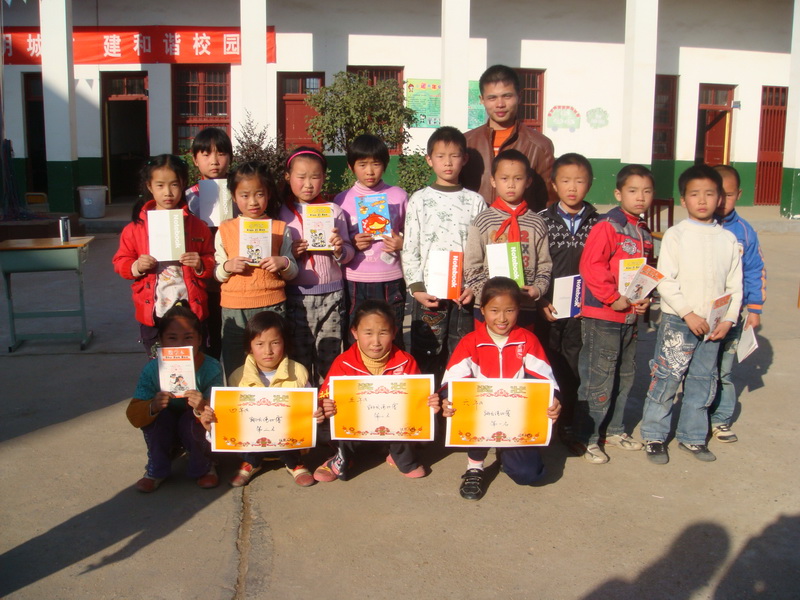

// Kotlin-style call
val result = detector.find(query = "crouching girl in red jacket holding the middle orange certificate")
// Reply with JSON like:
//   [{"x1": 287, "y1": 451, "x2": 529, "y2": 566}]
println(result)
[{"x1": 314, "y1": 300, "x2": 440, "y2": 481}]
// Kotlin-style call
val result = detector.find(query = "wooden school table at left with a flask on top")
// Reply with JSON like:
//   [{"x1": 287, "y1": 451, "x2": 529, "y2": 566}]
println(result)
[{"x1": 0, "y1": 236, "x2": 94, "y2": 352}]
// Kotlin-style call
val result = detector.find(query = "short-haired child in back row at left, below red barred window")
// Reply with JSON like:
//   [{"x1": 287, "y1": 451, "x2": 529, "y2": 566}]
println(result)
[{"x1": 186, "y1": 127, "x2": 233, "y2": 360}]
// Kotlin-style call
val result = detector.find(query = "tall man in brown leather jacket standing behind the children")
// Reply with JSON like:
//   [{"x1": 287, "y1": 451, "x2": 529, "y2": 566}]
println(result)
[{"x1": 461, "y1": 65, "x2": 557, "y2": 211}]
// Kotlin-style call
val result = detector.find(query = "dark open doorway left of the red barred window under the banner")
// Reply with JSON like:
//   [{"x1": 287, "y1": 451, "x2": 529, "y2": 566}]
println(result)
[{"x1": 101, "y1": 72, "x2": 150, "y2": 201}]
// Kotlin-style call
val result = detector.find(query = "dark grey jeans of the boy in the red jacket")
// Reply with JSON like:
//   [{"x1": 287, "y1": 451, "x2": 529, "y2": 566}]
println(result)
[{"x1": 576, "y1": 318, "x2": 637, "y2": 444}]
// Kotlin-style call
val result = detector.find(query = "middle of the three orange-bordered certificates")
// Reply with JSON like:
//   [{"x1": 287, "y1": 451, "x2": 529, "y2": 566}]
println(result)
[{"x1": 330, "y1": 375, "x2": 433, "y2": 442}]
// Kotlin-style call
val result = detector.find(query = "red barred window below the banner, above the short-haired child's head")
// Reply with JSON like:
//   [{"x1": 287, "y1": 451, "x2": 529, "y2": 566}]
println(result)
[{"x1": 172, "y1": 65, "x2": 231, "y2": 154}]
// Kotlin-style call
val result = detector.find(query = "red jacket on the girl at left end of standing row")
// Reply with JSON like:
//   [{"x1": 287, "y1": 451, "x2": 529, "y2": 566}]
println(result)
[{"x1": 112, "y1": 200, "x2": 214, "y2": 327}]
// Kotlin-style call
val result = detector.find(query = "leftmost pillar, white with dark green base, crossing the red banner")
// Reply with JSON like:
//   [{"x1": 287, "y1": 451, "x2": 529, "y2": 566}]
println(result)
[{"x1": 39, "y1": 0, "x2": 78, "y2": 212}]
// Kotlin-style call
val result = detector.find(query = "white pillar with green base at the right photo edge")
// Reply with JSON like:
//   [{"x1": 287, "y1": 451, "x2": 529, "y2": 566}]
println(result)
[{"x1": 781, "y1": 2, "x2": 800, "y2": 219}]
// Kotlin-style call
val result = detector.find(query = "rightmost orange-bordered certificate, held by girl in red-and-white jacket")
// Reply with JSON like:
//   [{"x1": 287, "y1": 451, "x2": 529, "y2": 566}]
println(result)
[{"x1": 445, "y1": 379, "x2": 553, "y2": 447}]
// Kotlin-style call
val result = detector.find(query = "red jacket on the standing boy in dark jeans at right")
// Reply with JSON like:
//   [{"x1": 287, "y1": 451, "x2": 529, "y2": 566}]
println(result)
[{"x1": 580, "y1": 207, "x2": 653, "y2": 324}]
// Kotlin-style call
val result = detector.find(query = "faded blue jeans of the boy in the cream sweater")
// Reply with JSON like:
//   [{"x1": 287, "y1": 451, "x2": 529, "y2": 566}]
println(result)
[{"x1": 642, "y1": 314, "x2": 720, "y2": 444}]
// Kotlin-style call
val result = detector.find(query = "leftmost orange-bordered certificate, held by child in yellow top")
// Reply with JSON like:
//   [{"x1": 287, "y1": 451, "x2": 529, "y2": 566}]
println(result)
[{"x1": 211, "y1": 387, "x2": 317, "y2": 452}]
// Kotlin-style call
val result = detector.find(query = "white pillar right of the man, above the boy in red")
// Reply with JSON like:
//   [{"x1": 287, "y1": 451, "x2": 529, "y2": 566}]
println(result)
[{"x1": 621, "y1": 0, "x2": 658, "y2": 165}]
